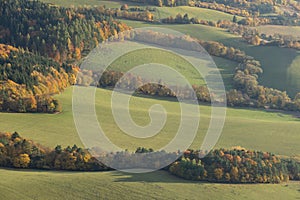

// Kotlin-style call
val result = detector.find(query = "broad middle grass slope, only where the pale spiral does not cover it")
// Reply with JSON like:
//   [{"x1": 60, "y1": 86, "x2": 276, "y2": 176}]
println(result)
[{"x1": 0, "y1": 88, "x2": 300, "y2": 155}]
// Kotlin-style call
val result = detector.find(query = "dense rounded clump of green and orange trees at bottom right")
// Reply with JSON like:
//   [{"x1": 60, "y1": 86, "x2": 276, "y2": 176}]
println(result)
[{"x1": 169, "y1": 148, "x2": 300, "y2": 183}]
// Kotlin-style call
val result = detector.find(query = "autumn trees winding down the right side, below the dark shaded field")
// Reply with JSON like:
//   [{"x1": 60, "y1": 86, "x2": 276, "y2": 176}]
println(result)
[{"x1": 200, "y1": 41, "x2": 300, "y2": 111}]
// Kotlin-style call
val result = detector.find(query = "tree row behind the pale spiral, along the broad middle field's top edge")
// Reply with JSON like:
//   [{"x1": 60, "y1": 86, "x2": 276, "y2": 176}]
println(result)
[{"x1": 77, "y1": 70, "x2": 211, "y2": 102}]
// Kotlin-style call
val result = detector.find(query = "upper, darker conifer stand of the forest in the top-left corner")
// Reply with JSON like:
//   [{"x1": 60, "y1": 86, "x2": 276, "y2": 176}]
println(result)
[{"x1": 0, "y1": 0, "x2": 128, "y2": 62}]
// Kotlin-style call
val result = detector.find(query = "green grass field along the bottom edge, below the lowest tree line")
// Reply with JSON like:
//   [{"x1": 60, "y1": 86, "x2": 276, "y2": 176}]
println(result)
[{"x1": 0, "y1": 169, "x2": 300, "y2": 200}]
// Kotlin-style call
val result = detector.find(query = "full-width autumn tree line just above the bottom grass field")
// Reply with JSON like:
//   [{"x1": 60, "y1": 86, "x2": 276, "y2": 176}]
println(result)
[{"x1": 0, "y1": 132, "x2": 300, "y2": 183}]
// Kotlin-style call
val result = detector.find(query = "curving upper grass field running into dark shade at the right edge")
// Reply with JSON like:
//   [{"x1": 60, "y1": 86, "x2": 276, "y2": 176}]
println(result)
[{"x1": 119, "y1": 20, "x2": 300, "y2": 97}]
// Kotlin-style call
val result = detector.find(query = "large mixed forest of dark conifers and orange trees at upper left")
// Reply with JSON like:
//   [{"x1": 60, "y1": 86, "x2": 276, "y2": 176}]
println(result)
[{"x1": 0, "y1": 0, "x2": 128, "y2": 113}]
